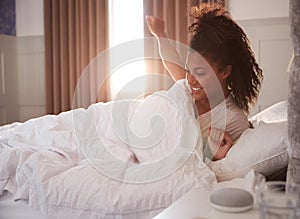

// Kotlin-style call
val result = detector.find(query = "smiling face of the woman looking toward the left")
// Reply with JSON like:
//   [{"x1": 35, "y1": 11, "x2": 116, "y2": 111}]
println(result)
[{"x1": 186, "y1": 52, "x2": 231, "y2": 109}]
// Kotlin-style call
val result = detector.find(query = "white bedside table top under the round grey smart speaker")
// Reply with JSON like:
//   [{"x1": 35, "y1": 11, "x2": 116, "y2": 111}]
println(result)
[{"x1": 154, "y1": 189, "x2": 259, "y2": 219}]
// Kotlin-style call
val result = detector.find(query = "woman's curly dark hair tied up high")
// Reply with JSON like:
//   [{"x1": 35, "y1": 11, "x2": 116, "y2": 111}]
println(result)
[{"x1": 189, "y1": 3, "x2": 263, "y2": 113}]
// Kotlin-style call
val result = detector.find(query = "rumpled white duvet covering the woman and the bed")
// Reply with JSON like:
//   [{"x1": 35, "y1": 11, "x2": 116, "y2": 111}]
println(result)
[{"x1": 0, "y1": 83, "x2": 253, "y2": 218}]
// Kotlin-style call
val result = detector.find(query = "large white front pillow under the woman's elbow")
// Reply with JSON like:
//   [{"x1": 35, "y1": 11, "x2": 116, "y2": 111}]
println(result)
[{"x1": 208, "y1": 121, "x2": 289, "y2": 181}]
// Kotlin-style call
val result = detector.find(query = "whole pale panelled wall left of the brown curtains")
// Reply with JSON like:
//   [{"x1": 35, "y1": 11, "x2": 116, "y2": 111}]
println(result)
[{"x1": 0, "y1": 0, "x2": 45, "y2": 124}]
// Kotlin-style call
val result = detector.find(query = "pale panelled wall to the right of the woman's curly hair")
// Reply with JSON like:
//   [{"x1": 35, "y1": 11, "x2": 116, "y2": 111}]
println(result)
[{"x1": 227, "y1": 0, "x2": 293, "y2": 114}]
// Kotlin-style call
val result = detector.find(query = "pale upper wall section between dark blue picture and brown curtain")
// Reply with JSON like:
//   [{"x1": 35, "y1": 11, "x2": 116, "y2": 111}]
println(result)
[{"x1": 16, "y1": 0, "x2": 44, "y2": 36}]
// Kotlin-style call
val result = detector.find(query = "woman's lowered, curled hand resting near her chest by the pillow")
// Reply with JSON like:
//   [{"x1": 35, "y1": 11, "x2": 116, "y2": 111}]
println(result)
[{"x1": 208, "y1": 128, "x2": 233, "y2": 160}]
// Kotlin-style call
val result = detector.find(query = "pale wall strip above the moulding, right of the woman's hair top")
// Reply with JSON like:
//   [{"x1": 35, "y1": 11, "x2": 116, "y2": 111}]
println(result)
[{"x1": 226, "y1": 0, "x2": 289, "y2": 20}]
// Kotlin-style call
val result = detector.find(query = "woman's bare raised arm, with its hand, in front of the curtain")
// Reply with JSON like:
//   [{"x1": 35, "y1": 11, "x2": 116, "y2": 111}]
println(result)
[{"x1": 146, "y1": 16, "x2": 185, "y2": 81}]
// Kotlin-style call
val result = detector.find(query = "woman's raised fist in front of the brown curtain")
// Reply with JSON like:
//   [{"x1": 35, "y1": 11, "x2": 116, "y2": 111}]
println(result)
[{"x1": 146, "y1": 15, "x2": 167, "y2": 38}]
